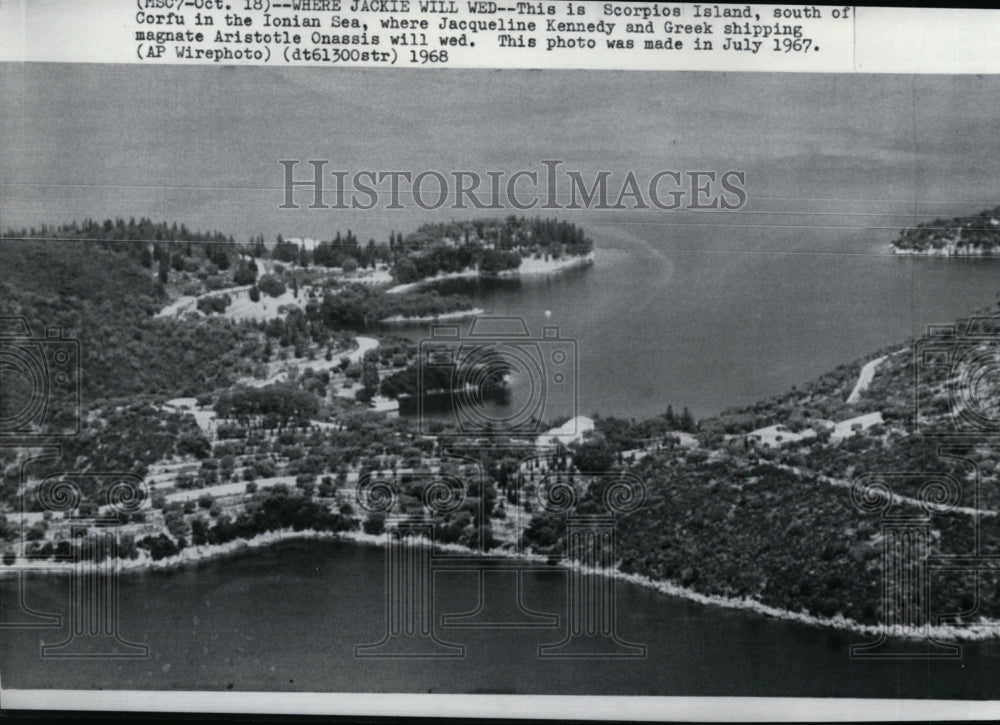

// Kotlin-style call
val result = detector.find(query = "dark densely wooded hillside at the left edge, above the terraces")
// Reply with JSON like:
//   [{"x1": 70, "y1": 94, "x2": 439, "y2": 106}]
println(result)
[{"x1": 0, "y1": 240, "x2": 262, "y2": 402}]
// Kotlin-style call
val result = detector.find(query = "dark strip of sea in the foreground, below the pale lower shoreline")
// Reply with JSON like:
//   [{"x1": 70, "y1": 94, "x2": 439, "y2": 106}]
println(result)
[{"x1": 0, "y1": 541, "x2": 1000, "y2": 698}]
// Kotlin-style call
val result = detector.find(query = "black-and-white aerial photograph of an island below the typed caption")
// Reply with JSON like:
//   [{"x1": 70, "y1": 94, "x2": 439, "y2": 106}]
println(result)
[{"x1": 0, "y1": 63, "x2": 1000, "y2": 700}]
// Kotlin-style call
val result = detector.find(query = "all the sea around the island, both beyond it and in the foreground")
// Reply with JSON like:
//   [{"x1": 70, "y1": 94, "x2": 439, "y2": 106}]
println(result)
[{"x1": 0, "y1": 64, "x2": 1000, "y2": 698}]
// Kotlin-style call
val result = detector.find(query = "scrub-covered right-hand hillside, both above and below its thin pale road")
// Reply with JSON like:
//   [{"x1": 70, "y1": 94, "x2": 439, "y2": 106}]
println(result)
[{"x1": 524, "y1": 304, "x2": 1000, "y2": 623}]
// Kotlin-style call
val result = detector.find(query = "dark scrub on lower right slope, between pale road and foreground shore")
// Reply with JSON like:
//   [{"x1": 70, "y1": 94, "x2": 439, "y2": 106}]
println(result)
[{"x1": 592, "y1": 446, "x2": 1000, "y2": 623}]
